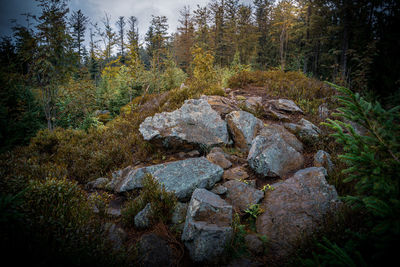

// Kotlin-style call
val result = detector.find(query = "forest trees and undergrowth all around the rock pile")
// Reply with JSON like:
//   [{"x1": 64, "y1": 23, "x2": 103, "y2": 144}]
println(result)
[{"x1": 0, "y1": 0, "x2": 400, "y2": 266}]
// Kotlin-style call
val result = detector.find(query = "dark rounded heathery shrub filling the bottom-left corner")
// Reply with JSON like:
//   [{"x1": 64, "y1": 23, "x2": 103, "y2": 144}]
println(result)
[{"x1": 1, "y1": 178, "x2": 119, "y2": 266}]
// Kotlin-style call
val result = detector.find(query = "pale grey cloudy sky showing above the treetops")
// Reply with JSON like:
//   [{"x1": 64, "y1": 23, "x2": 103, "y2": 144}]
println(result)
[{"x1": 0, "y1": 0, "x2": 220, "y2": 43}]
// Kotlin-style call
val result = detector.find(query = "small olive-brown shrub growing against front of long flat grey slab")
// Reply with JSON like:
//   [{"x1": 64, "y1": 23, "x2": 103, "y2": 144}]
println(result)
[{"x1": 122, "y1": 174, "x2": 177, "y2": 226}]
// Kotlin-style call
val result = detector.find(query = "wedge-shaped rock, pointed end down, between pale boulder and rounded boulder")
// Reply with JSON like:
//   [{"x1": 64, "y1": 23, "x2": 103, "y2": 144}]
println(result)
[{"x1": 226, "y1": 111, "x2": 263, "y2": 152}]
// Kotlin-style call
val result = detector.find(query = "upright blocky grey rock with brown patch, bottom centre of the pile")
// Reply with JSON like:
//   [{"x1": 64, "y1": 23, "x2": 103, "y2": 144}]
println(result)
[{"x1": 182, "y1": 189, "x2": 233, "y2": 262}]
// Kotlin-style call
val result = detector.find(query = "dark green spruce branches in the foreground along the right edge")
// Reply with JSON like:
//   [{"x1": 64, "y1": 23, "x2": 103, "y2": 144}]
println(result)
[{"x1": 306, "y1": 84, "x2": 400, "y2": 266}]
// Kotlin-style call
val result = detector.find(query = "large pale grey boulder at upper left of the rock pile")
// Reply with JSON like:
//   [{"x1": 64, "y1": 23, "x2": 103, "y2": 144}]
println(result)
[{"x1": 139, "y1": 99, "x2": 229, "y2": 151}]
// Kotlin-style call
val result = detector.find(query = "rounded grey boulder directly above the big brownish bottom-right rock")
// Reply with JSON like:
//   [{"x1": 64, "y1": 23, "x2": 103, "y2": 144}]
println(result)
[{"x1": 247, "y1": 126, "x2": 304, "y2": 177}]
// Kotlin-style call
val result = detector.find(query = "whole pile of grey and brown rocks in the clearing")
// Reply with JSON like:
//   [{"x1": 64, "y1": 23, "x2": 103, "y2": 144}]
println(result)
[{"x1": 90, "y1": 96, "x2": 338, "y2": 265}]
